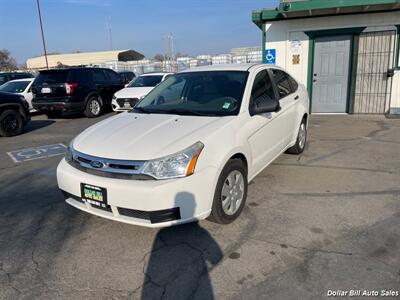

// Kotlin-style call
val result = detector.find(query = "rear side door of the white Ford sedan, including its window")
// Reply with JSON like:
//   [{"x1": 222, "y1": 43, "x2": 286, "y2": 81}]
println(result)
[{"x1": 270, "y1": 69, "x2": 299, "y2": 147}]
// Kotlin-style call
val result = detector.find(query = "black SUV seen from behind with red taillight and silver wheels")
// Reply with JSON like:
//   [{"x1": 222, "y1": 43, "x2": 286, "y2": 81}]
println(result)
[{"x1": 32, "y1": 67, "x2": 124, "y2": 118}]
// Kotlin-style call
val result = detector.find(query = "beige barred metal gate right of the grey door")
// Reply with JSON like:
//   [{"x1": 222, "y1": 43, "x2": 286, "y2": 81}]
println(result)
[{"x1": 354, "y1": 31, "x2": 396, "y2": 114}]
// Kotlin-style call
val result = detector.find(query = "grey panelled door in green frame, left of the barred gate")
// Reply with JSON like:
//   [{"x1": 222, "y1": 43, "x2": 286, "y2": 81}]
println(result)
[{"x1": 311, "y1": 35, "x2": 351, "y2": 113}]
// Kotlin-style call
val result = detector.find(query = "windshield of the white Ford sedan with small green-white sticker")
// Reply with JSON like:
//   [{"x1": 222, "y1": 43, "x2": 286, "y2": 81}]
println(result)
[{"x1": 133, "y1": 71, "x2": 248, "y2": 116}]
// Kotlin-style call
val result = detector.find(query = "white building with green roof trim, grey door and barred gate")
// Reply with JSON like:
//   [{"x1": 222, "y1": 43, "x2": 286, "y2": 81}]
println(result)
[{"x1": 252, "y1": 0, "x2": 400, "y2": 114}]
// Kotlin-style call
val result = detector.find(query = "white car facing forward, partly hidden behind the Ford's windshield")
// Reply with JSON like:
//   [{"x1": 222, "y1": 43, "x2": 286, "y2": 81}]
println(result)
[{"x1": 111, "y1": 73, "x2": 172, "y2": 112}]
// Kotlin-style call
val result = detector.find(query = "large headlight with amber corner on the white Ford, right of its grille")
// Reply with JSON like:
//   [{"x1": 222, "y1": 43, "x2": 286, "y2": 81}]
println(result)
[{"x1": 142, "y1": 142, "x2": 204, "y2": 179}]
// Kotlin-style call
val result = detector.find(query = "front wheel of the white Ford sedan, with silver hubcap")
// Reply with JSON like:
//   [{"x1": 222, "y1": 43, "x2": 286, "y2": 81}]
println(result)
[{"x1": 208, "y1": 159, "x2": 247, "y2": 224}]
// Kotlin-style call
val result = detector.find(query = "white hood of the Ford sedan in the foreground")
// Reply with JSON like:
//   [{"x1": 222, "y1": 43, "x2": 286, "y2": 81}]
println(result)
[{"x1": 73, "y1": 113, "x2": 234, "y2": 160}]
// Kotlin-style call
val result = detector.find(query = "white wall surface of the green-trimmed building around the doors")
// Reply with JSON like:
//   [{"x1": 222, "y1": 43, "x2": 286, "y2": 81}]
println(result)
[{"x1": 265, "y1": 11, "x2": 400, "y2": 110}]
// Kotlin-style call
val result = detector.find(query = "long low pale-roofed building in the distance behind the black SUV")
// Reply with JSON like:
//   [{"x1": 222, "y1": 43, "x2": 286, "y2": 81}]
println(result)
[{"x1": 26, "y1": 50, "x2": 144, "y2": 70}]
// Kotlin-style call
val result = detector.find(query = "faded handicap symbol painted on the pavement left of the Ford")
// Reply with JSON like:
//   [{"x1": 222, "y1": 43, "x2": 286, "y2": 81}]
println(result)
[{"x1": 7, "y1": 144, "x2": 67, "y2": 163}]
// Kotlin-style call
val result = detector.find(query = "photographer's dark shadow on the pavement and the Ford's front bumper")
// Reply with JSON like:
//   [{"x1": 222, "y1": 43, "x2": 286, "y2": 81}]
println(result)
[{"x1": 141, "y1": 192, "x2": 223, "y2": 300}]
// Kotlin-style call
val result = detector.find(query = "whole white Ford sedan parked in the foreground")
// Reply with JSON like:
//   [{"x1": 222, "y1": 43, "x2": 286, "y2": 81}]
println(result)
[{"x1": 57, "y1": 64, "x2": 309, "y2": 227}]
